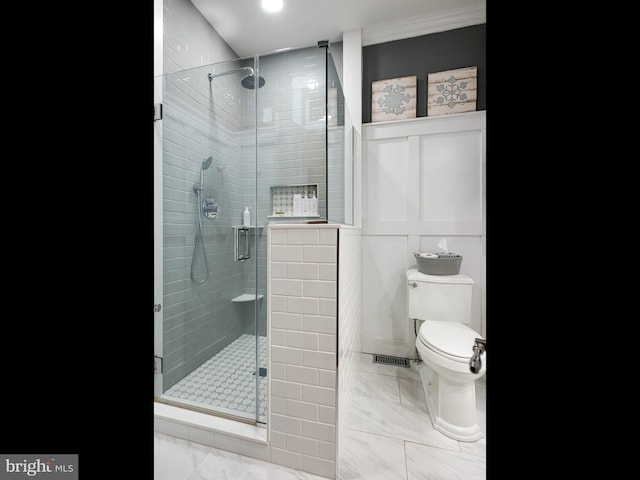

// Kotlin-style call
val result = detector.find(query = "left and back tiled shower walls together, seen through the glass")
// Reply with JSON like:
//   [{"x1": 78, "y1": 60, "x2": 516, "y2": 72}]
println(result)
[{"x1": 163, "y1": 47, "x2": 344, "y2": 388}]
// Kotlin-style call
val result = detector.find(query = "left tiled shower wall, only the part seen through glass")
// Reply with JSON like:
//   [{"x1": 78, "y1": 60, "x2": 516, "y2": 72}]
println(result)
[{"x1": 162, "y1": 63, "x2": 249, "y2": 388}]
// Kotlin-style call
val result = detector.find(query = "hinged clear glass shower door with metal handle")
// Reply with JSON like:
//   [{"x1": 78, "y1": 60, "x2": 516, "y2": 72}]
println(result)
[{"x1": 154, "y1": 57, "x2": 267, "y2": 423}]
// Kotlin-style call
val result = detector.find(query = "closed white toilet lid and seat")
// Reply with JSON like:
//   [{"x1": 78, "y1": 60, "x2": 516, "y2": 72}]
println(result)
[{"x1": 418, "y1": 320, "x2": 484, "y2": 361}]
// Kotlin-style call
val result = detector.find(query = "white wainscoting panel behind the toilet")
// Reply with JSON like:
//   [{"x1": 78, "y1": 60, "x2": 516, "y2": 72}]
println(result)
[{"x1": 362, "y1": 111, "x2": 486, "y2": 358}]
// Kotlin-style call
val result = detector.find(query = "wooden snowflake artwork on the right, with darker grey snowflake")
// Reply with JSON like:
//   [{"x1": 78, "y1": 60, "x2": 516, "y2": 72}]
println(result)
[{"x1": 427, "y1": 67, "x2": 478, "y2": 117}]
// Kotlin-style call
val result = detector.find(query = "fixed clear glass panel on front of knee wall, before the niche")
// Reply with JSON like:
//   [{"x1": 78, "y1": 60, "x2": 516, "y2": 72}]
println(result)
[{"x1": 258, "y1": 46, "x2": 327, "y2": 223}]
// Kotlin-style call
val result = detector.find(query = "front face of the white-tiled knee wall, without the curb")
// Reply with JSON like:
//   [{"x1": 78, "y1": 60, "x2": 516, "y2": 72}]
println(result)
[{"x1": 268, "y1": 225, "x2": 338, "y2": 478}]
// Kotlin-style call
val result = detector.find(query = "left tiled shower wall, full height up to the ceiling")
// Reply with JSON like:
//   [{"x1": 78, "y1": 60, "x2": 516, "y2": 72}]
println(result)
[{"x1": 162, "y1": 0, "x2": 255, "y2": 389}]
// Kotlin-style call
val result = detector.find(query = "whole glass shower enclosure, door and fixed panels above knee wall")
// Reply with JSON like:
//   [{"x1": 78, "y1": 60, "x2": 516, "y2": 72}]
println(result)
[{"x1": 154, "y1": 45, "x2": 345, "y2": 424}]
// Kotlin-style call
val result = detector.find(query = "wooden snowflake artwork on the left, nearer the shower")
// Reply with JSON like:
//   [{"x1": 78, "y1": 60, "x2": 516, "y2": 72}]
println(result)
[{"x1": 371, "y1": 75, "x2": 418, "y2": 122}]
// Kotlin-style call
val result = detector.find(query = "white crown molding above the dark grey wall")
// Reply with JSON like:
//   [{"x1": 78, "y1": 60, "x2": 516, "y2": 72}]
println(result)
[{"x1": 362, "y1": 2, "x2": 487, "y2": 46}]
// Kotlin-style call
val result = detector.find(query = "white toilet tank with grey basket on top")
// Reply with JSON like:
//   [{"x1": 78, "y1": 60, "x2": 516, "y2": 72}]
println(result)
[{"x1": 407, "y1": 268, "x2": 474, "y2": 325}]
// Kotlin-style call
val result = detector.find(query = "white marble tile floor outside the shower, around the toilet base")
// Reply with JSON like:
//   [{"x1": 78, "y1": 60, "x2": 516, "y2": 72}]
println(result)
[{"x1": 154, "y1": 354, "x2": 486, "y2": 480}]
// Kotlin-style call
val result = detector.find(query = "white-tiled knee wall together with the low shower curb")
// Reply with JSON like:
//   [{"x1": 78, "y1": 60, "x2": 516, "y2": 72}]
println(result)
[{"x1": 155, "y1": 225, "x2": 348, "y2": 478}]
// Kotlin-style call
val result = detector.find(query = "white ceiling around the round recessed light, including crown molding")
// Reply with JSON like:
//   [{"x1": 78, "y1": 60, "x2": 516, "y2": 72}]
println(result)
[{"x1": 191, "y1": 0, "x2": 486, "y2": 57}]
